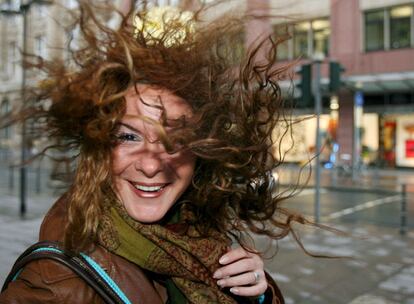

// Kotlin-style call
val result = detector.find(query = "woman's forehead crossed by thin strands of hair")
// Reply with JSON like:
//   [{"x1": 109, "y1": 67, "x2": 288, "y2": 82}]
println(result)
[{"x1": 125, "y1": 84, "x2": 192, "y2": 120}]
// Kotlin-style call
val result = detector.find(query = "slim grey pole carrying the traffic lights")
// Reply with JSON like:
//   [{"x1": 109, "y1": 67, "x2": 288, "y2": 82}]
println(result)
[{"x1": 314, "y1": 60, "x2": 322, "y2": 223}]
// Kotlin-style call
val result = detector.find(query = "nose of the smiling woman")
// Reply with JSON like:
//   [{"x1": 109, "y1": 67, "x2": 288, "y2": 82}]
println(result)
[{"x1": 135, "y1": 142, "x2": 165, "y2": 178}]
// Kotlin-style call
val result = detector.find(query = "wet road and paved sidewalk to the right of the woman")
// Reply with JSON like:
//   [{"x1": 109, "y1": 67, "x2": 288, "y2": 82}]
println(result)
[{"x1": 268, "y1": 189, "x2": 414, "y2": 304}]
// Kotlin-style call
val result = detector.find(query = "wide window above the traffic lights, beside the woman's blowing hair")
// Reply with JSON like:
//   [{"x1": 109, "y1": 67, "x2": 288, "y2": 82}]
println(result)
[{"x1": 274, "y1": 18, "x2": 331, "y2": 60}]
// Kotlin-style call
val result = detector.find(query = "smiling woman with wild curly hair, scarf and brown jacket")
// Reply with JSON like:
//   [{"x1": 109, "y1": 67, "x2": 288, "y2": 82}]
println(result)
[{"x1": 0, "y1": 3, "x2": 300, "y2": 303}]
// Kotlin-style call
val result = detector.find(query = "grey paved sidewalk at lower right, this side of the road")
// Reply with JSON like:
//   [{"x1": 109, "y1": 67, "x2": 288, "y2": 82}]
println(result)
[{"x1": 266, "y1": 225, "x2": 414, "y2": 304}]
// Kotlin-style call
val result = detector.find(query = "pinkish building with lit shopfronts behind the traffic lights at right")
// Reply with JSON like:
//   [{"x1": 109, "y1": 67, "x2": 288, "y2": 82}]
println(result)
[{"x1": 262, "y1": 0, "x2": 414, "y2": 167}]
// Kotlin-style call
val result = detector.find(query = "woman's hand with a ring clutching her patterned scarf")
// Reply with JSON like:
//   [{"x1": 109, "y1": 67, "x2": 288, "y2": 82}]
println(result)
[{"x1": 213, "y1": 247, "x2": 267, "y2": 297}]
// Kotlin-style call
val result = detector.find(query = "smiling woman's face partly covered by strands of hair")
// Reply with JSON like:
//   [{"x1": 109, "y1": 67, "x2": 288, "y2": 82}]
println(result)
[{"x1": 112, "y1": 85, "x2": 195, "y2": 223}]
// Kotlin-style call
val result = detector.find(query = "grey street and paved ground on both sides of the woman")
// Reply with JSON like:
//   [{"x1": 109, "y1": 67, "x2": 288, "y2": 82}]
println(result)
[{"x1": 0, "y1": 166, "x2": 414, "y2": 304}]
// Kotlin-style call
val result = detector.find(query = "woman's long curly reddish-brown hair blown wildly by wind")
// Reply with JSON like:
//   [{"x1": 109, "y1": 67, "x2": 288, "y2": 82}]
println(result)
[{"x1": 22, "y1": 2, "x2": 305, "y2": 250}]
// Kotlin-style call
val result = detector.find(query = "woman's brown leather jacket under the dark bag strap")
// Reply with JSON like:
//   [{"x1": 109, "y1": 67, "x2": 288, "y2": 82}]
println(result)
[{"x1": 0, "y1": 199, "x2": 283, "y2": 304}]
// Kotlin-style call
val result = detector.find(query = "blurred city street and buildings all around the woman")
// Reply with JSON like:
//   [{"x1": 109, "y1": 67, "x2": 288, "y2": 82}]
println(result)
[{"x1": 0, "y1": 0, "x2": 414, "y2": 304}]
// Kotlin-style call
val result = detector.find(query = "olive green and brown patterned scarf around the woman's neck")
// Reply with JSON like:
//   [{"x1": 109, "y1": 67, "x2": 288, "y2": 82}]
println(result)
[{"x1": 99, "y1": 204, "x2": 237, "y2": 304}]
